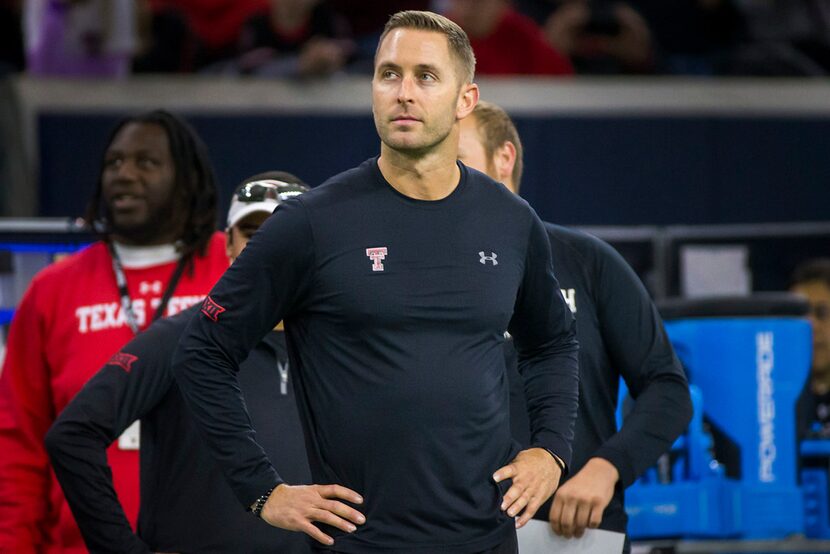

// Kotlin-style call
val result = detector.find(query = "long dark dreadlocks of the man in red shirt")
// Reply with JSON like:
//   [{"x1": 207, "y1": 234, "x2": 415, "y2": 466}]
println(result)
[{"x1": 84, "y1": 110, "x2": 217, "y2": 266}]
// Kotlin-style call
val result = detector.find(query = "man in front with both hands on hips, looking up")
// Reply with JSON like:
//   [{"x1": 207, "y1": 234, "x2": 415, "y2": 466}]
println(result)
[{"x1": 174, "y1": 11, "x2": 577, "y2": 554}]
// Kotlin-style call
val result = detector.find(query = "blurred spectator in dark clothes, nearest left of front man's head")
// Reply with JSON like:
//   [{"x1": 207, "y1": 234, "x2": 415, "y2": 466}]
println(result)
[{"x1": 214, "y1": 0, "x2": 354, "y2": 77}]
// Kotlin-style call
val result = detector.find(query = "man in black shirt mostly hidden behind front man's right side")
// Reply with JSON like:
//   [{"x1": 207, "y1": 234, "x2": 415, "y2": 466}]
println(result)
[{"x1": 459, "y1": 98, "x2": 692, "y2": 537}]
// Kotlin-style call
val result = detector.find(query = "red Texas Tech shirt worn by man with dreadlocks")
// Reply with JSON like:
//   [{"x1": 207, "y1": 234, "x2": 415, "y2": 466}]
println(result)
[{"x1": 0, "y1": 233, "x2": 228, "y2": 554}]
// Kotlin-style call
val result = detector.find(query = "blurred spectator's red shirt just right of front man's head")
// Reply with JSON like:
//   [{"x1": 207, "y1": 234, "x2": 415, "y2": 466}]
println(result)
[{"x1": 470, "y1": 8, "x2": 574, "y2": 75}]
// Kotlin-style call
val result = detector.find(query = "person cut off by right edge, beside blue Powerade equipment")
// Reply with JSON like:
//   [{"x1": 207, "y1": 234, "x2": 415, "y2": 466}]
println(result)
[{"x1": 790, "y1": 258, "x2": 830, "y2": 438}]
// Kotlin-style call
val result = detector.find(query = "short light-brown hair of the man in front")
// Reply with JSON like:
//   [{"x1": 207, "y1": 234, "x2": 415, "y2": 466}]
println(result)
[{"x1": 375, "y1": 10, "x2": 476, "y2": 84}]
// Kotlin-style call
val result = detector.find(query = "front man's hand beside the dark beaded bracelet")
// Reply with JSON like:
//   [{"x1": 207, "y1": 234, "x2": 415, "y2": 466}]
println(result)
[{"x1": 260, "y1": 484, "x2": 366, "y2": 546}]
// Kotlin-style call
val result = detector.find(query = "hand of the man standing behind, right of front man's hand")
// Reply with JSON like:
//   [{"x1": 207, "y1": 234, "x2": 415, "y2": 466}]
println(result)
[{"x1": 550, "y1": 458, "x2": 620, "y2": 537}]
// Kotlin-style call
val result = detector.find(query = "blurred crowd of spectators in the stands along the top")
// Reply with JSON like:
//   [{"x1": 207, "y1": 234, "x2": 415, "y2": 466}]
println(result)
[{"x1": 0, "y1": 0, "x2": 830, "y2": 78}]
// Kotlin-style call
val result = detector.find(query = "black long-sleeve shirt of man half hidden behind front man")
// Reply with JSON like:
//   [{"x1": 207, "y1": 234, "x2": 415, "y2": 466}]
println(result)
[{"x1": 506, "y1": 223, "x2": 692, "y2": 532}]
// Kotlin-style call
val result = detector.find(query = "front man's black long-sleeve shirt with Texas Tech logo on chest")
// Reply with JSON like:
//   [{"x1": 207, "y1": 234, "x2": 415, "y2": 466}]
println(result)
[{"x1": 174, "y1": 159, "x2": 578, "y2": 553}]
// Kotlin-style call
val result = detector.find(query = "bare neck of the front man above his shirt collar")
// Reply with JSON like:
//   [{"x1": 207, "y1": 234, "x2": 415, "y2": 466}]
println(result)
[{"x1": 378, "y1": 144, "x2": 461, "y2": 200}]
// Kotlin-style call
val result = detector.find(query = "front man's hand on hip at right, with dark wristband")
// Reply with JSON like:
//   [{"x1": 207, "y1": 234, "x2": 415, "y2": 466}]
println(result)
[{"x1": 493, "y1": 448, "x2": 562, "y2": 529}]
